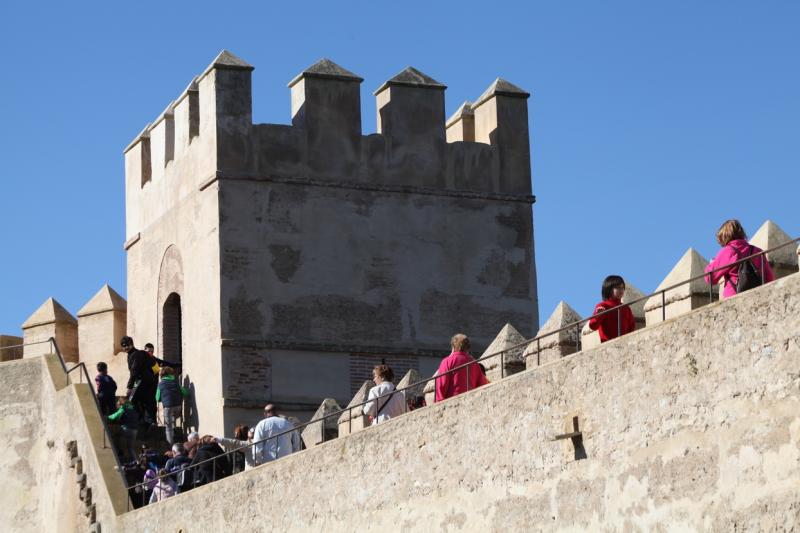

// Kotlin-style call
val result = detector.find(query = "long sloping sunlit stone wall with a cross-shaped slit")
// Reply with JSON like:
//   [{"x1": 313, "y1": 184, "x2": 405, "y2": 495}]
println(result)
[{"x1": 112, "y1": 275, "x2": 800, "y2": 531}]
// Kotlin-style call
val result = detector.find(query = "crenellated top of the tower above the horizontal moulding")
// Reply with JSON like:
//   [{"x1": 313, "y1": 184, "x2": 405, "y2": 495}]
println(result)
[{"x1": 124, "y1": 51, "x2": 533, "y2": 239}]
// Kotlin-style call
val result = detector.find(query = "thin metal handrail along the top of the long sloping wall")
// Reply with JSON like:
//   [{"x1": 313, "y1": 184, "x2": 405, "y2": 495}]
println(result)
[{"x1": 128, "y1": 237, "x2": 800, "y2": 509}]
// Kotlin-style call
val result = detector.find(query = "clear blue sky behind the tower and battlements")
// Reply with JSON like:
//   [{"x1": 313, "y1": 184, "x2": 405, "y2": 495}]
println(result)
[{"x1": 0, "y1": 0, "x2": 800, "y2": 334}]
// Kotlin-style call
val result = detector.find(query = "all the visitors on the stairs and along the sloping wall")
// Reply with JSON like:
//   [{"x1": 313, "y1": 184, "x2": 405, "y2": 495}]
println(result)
[{"x1": 95, "y1": 216, "x2": 775, "y2": 503}]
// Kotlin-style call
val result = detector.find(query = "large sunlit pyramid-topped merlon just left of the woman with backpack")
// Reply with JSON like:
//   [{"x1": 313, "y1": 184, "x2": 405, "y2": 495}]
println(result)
[{"x1": 644, "y1": 248, "x2": 718, "y2": 326}]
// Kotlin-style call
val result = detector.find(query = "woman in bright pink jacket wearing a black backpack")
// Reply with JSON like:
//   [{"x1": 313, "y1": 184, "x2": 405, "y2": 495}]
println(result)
[{"x1": 706, "y1": 220, "x2": 775, "y2": 298}]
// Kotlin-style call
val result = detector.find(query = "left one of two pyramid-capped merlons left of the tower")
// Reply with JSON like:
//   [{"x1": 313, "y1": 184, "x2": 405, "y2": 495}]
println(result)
[{"x1": 22, "y1": 298, "x2": 78, "y2": 363}]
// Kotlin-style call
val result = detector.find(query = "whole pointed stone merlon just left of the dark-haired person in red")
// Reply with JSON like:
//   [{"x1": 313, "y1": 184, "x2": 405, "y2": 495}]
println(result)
[{"x1": 524, "y1": 301, "x2": 581, "y2": 368}]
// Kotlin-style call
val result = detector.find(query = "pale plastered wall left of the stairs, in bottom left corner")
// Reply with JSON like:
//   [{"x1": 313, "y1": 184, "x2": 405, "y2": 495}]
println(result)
[{"x1": 0, "y1": 354, "x2": 127, "y2": 532}]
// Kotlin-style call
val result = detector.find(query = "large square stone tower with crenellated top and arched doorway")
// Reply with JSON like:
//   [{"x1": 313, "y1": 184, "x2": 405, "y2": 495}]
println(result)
[{"x1": 125, "y1": 51, "x2": 538, "y2": 432}]
